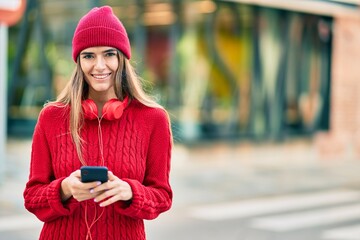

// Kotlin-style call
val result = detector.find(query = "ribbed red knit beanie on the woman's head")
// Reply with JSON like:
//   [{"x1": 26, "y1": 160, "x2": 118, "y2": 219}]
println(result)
[{"x1": 72, "y1": 6, "x2": 131, "y2": 62}]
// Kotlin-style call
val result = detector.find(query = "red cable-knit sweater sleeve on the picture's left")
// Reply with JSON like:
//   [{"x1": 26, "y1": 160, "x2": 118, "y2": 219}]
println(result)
[{"x1": 24, "y1": 108, "x2": 78, "y2": 222}]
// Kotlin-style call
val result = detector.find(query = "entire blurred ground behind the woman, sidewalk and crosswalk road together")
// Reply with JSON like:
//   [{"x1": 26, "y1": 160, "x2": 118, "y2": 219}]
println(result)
[{"x1": 0, "y1": 141, "x2": 360, "y2": 240}]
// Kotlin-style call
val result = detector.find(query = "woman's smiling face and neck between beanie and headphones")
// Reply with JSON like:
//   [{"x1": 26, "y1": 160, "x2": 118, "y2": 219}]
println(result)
[{"x1": 80, "y1": 47, "x2": 119, "y2": 100}]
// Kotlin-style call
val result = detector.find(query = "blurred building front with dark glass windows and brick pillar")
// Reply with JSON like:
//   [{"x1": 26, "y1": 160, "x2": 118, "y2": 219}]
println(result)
[{"x1": 8, "y1": 0, "x2": 360, "y2": 158}]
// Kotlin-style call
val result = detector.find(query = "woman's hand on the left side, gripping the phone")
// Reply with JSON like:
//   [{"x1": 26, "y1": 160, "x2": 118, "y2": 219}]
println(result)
[{"x1": 61, "y1": 170, "x2": 101, "y2": 202}]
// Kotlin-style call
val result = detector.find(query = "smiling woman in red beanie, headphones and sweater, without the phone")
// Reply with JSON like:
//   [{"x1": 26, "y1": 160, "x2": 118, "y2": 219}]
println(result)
[{"x1": 24, "y1": 6, "x2": 172, "y2": 240}]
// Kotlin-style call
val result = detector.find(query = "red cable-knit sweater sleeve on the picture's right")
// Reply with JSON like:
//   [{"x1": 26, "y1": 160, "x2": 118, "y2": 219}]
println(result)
[{"x1": 115, "y1": 109, "x2": 172, "y2": 219}]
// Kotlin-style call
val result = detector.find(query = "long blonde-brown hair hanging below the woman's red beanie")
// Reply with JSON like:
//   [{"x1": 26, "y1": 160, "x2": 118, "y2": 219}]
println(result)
[{"x1": 47, "y1": 51, "x2": 163, "y2": 165}]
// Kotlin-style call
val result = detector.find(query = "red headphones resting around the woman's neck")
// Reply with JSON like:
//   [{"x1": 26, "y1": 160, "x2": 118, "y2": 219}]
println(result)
[{"x1": 81, "y1": 97, "x2": 128, "y2": 120}]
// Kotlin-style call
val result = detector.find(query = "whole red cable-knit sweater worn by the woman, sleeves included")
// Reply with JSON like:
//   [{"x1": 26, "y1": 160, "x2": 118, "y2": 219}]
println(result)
[{"x1": 24, "y1": 100, "x2": 172, "y2": 240}]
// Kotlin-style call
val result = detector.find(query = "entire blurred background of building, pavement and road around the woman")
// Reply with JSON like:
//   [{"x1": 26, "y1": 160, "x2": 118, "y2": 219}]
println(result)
[{"x1": 0, "y1": 0, "x2": 360, "y2": 240}]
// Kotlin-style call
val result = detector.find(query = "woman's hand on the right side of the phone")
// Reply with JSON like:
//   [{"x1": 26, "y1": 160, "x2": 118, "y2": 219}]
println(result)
[{"x1": 92, "y1": 171, "x2": 133, "y2": 207}]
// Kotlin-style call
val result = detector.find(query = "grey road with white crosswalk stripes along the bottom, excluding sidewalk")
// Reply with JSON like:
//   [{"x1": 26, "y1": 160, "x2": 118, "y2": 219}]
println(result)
[{"x1": 0, "y1": 189, "x2": 360, "y2": 240}]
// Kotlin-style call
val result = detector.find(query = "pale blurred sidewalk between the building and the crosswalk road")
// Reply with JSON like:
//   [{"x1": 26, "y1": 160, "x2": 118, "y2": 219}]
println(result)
[{"x1": 0, "y1": 139, "x2": 360, "y2": 217}]
